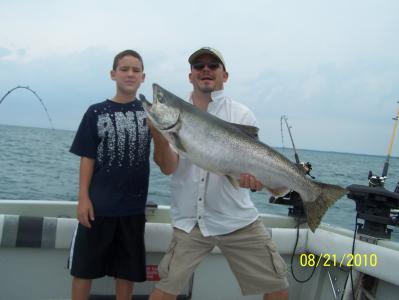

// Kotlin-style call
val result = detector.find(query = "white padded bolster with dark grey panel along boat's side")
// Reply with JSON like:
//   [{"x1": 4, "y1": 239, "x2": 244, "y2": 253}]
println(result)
[{"x1": 0, "y1": 214, "x2": 173, "y2": 252}]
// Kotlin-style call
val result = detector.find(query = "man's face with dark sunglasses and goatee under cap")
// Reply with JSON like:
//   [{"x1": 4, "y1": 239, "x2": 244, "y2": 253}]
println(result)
[{"x1": 188, "y1": 54, "x2": 228, "y2": 93}]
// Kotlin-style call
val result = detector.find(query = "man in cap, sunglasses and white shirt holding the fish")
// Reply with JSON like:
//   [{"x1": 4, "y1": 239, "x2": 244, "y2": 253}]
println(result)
[{"x1": 150, "y1": 47, "x2": 288, "y2": 300}]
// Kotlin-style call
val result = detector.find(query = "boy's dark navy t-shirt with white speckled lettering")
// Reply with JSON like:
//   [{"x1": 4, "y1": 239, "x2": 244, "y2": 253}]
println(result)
[{"x1": 70, "y1": 99, "x2": 151, "y2": 216}]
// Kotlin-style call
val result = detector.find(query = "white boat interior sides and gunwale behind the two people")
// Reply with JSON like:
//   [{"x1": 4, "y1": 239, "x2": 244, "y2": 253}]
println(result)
[{"x1": 0, "y1": 200, "x2": 399, "y2": 300}]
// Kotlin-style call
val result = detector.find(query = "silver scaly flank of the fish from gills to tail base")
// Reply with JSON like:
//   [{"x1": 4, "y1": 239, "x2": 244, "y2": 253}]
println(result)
[{"x1": 175, "y1": 106, "x2": 313, "y2": 200}]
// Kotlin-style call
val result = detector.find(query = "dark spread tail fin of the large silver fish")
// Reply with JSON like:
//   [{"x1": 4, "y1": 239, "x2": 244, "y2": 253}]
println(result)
[{"x1": 303, "y1": 182, "x2": 348, "y2": 232}]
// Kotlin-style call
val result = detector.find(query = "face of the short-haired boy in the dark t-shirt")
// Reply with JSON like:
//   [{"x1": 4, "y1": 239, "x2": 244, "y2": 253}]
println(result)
[{"x1": 111, "y1": 55, "x2": 145, "y2": 94}]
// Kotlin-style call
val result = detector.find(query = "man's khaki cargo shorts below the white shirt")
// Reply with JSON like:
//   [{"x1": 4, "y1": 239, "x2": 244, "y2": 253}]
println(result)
[{"x1": 156, "y1": 219, "x2": 288, "y2": 295}]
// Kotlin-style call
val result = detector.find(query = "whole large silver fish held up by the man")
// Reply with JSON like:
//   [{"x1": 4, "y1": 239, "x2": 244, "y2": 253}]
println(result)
[{"x1": 139, "y1": 83, "x2": 348, "y2": 232}]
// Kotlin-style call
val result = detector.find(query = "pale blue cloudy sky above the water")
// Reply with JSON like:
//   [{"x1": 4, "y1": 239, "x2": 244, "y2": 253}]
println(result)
[{"x1": 0, "y1": 0, "x2": 399, "y2": 156}]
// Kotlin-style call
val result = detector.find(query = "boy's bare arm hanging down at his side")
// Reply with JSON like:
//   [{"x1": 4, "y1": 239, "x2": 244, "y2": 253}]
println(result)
[{"x1": 77, "y1": 157, "x2": 95, "y2": 228}]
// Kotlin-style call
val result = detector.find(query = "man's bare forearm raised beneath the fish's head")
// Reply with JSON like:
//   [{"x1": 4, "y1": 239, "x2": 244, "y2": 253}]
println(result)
[{"x1": 149, "y1": 122, "x2": 179, "y2": 175}]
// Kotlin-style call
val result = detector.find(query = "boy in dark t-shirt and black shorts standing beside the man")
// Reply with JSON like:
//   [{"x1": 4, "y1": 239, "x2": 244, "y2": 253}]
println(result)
[{"x1": 69, "y1": 50, "x2": 151, "y2": 300}]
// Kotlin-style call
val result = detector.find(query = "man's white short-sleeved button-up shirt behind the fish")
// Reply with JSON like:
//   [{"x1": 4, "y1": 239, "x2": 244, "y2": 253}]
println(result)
[{"x1": 171, "y1": 90, "x2": 258, "y2": 236}]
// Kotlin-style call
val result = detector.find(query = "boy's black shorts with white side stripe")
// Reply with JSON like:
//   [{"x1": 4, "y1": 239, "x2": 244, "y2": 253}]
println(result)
[{"x1": 68, "y1": 215, "x2": 146, "y2": 282}]
